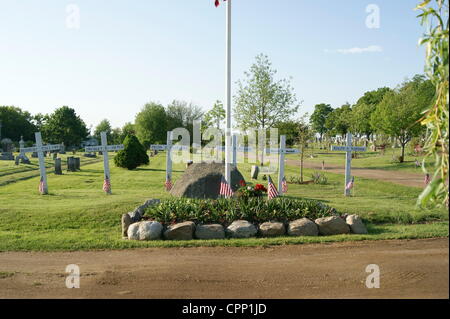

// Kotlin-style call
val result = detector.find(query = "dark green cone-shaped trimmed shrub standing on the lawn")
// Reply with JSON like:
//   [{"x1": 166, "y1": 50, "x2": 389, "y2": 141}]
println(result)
[{"x1": 114, "y1": 135, "x2": 149, "y2": 170}]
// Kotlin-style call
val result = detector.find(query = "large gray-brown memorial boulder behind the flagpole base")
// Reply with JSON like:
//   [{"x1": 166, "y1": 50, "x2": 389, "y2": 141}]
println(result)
[{"x1": 170, "y1": 163, "x2": 244, "y2": 199}]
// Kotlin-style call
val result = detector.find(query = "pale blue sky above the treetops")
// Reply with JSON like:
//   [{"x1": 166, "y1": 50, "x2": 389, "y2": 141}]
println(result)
[{"x1": 0, "y1": 0, "x2": 424, "y2": 130}]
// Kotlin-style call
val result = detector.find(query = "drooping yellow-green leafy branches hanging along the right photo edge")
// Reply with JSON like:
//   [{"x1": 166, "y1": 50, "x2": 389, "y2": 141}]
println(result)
[{"x1": 416, "y1": 0, "x2": 449, "y2": 206}]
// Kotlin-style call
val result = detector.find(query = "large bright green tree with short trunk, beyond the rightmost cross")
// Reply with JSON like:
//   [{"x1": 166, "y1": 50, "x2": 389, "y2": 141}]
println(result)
[{"x1": 371, "y1": 75, "x2": 434, "y2": 162}]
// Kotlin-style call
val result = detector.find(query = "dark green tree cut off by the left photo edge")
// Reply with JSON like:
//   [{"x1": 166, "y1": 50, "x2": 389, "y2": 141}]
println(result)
[{"x1": 0, "y1": 106, "x2": 36, "y2": 141}]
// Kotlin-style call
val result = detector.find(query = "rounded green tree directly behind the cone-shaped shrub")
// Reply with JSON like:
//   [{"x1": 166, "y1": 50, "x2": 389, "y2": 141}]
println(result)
[{"x1": 135, "y1": 102, "x2": 167, "y2": 148}]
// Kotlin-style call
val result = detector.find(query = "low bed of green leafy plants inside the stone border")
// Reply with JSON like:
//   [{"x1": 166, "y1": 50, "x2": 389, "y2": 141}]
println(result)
[{"x1": 144, "y1": 197, "x2": 337, "y2": 226}]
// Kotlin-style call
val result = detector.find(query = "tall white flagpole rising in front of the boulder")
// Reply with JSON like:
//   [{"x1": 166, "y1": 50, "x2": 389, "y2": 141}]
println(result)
[{"x1": 225, "y1": 0, "x2": 232, "y2": 186}]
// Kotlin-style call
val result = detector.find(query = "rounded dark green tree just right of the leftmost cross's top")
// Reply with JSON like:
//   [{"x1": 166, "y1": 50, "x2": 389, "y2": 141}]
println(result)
[{"x1": 42, "y1": 106, "x2": 89, "y2": 147}]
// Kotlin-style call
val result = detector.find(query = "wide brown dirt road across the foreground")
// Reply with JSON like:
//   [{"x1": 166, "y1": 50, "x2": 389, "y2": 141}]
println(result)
[{"x1": 0, "y1": 238, "x2": 449, "y2": 298}]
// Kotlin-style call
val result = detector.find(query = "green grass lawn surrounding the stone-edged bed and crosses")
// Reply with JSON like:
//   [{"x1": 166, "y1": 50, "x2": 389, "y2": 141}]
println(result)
[{"x1": 0, "y1": 154, "x2": 448, "y2": 251}]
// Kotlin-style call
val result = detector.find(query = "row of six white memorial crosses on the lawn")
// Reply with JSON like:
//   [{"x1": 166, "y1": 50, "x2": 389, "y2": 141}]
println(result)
[{"x1": 20, "y1": 132, "x2": 366, "y2": 196}]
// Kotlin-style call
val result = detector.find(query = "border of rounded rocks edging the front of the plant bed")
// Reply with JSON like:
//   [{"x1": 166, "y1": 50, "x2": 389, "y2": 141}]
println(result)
[{"x1": 122, "y1": 199, "x2": 368, "y2": 240}]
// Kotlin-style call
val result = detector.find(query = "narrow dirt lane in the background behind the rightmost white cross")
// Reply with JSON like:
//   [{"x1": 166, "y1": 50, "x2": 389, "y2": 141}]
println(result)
[{"x1": 286, "y1": 160, "x2": 424, "y2": 187}]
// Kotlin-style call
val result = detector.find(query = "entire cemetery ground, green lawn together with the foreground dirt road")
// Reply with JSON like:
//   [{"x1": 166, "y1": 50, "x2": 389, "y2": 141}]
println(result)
[{"x1": 0, "y1": 150, "x2": 449, "y2": 298}]
